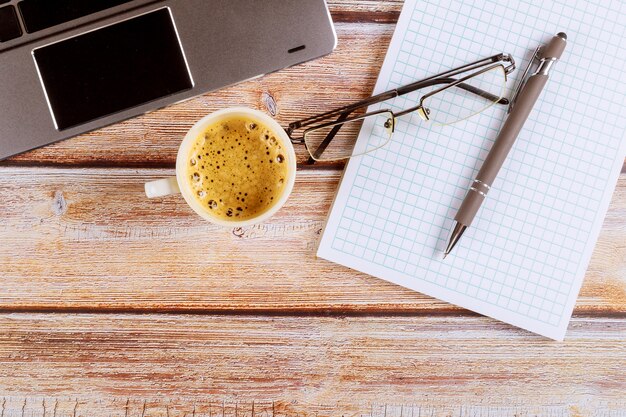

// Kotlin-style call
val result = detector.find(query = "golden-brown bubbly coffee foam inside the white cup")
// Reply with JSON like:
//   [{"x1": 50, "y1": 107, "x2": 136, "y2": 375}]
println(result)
[{"x1": 187, "y1": 117, "x2": 289, "y2": 220}]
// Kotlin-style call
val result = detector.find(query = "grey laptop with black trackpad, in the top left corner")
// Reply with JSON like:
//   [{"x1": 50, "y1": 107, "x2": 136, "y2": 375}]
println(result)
[{"x1": 0, "y1": 0, "x2": 337, "y2": 159}]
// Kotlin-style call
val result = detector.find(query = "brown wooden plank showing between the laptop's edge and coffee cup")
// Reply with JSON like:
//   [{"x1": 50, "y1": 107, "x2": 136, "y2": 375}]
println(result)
[{"x1": 0, "y1": 23, "x2": 394, "y2": 167}]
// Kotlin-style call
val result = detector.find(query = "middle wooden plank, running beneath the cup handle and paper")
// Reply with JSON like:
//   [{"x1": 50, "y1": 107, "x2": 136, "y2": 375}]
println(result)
[{"x1": 0, "y1": 167, "x2": 626, "y2": 317}]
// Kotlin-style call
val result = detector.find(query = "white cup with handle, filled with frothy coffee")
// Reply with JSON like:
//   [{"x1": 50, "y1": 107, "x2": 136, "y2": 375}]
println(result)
[{"x1": 145, "y1": 108, "x2": 296, "y2": 226}]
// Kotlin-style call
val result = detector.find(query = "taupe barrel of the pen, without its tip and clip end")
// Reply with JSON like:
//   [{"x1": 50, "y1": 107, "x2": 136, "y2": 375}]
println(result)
[{"x1": 454, "y1": 74, "x2": 548, "y2": 226}]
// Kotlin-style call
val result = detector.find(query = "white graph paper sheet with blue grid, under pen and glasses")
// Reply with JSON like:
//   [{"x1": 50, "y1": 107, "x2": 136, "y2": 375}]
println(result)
[{"x1": 318, "y1": 0, "x2": 626, "y2": 340}]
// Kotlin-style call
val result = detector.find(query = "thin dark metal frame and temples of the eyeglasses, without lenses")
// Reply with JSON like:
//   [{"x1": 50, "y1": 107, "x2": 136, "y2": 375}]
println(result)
[{"x1": 285, "y1": 53, "x2": 515, "y2": 164}]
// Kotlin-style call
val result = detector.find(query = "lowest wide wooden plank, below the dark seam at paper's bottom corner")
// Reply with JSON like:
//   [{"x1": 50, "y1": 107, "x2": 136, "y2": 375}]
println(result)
[{"x1": 0, "y1": 313, "x2": 626, "y2": 408}]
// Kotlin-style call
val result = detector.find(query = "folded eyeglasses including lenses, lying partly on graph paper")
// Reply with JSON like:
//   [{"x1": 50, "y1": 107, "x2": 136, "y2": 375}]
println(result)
[{"x1": 285, "y1": 54, "x2": 515, "y2": 163}]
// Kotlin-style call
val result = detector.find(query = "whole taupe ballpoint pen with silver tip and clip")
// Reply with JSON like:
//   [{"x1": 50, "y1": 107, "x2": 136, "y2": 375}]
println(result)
[{"x1": 444, "y1": 32, "x2": 567, "y2": 258}]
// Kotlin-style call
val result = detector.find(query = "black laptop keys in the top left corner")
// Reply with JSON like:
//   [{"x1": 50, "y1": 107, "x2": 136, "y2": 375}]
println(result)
[{"x1": 0, "y1": 0, "x2": 133, "y2": 43}]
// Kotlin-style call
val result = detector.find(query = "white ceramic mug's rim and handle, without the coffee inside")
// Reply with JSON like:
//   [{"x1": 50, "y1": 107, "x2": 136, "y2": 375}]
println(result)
[{"x1": 145, "y1": 107, "x2": 296, "y2": 227}]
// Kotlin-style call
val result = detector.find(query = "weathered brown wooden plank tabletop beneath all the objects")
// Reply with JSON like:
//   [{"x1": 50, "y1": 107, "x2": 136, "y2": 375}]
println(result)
[{"x1": 0, "y1": 0, "x2": 626, "y2": 417}]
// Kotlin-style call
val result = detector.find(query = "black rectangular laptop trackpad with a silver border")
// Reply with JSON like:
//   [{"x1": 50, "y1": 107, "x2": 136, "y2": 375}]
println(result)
[{"x1": 33, "y1": 8, "x2": 193, "y2": 130}]
